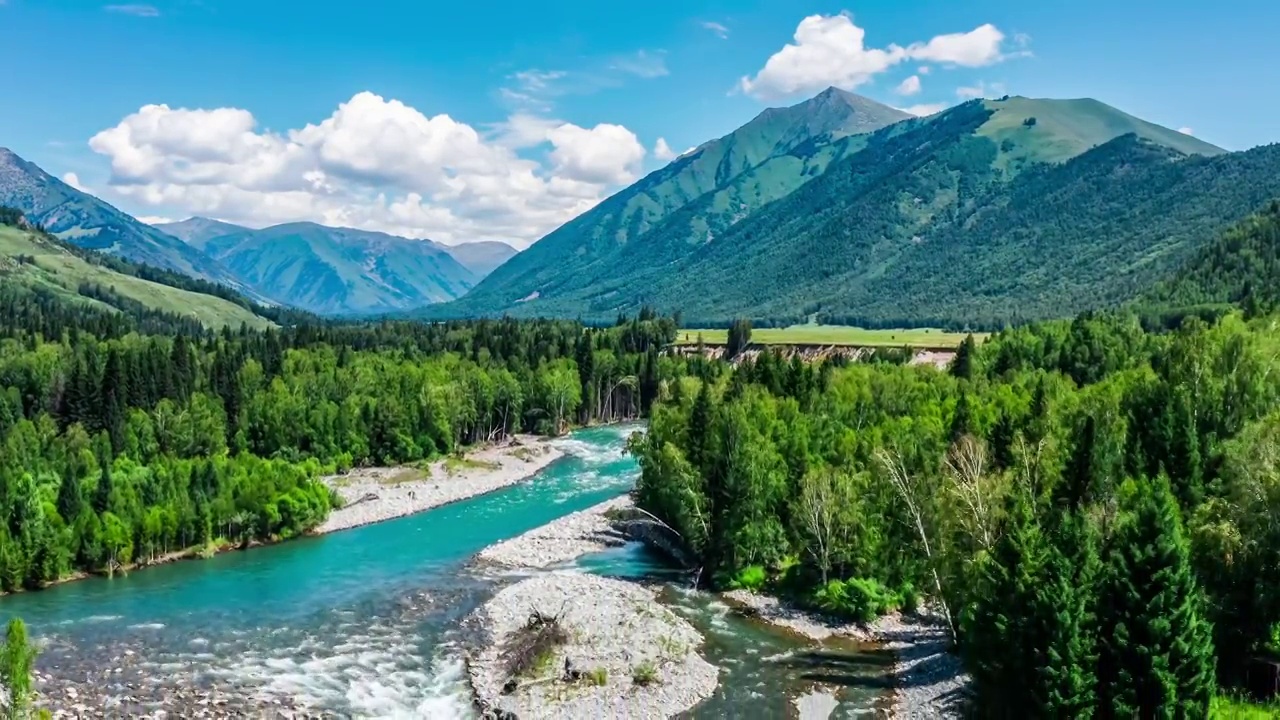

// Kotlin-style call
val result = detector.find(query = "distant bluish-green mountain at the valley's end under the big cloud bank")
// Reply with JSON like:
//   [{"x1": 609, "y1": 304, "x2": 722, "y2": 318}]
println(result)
[{"x1": 194, "y1": 223, "x2": 477, "y2": 315}]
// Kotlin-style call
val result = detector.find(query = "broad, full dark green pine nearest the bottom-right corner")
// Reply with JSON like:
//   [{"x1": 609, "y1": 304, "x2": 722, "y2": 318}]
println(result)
[{"x1": 1098, "y1": 475, "x2": 1216, "y2": 720}]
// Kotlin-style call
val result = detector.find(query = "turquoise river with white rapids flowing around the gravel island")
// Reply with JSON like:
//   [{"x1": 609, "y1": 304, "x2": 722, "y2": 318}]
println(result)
[{"x1": 0, "y1": 427, "x2": 886, "y2": 720}]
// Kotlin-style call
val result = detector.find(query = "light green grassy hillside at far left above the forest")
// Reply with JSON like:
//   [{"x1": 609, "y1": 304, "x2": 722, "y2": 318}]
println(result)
[{"x1": 0, "y1": 220, "x2": 273, "y2": 328}]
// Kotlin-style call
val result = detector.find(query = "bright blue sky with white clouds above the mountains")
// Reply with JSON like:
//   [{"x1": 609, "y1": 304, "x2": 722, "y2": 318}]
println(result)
[{"x1": 0, "y1": 0, "x2": 1280, "y2": 243}]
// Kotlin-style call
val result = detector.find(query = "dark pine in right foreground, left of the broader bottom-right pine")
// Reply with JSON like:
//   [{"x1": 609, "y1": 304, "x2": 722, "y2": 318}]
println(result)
[{"x1": 963, "y1": 491, "x2": 1047, "y2": 719}]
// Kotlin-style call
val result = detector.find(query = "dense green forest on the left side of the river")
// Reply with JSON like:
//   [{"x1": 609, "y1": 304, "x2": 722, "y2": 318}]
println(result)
[{"x1": 0, "y1": 219, "x2": 680, "y2": 591}]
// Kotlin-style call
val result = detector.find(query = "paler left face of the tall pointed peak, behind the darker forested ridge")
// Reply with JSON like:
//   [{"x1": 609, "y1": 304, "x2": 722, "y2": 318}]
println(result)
[{"x1": 448, "y1": 88, "x2": 910, "y2": 314}]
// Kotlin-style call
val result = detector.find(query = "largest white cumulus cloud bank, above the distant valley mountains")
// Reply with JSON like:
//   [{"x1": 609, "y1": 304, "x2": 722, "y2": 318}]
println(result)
[{"x1": 90, "y1": 92, "x2": 645, "y2": 245}]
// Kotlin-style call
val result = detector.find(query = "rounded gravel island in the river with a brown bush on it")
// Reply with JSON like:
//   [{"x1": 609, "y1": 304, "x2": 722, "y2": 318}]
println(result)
[{"x1": 467, "y1": 571, "x2": 718, "y2": 720}]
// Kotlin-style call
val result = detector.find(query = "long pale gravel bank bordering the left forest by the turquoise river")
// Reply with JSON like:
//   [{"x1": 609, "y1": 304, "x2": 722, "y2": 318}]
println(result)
[{"x1": 314, "y1": 436, "x2": 564, "y2": 534}]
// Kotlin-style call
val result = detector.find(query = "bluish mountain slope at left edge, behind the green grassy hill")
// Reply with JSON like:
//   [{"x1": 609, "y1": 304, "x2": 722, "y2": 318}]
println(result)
[{"x1": 0, "y1": 147, "x2": 239, "y2": 286}]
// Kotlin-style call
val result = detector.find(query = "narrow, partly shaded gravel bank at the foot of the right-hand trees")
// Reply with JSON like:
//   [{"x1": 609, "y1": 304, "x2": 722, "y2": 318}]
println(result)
[{"x1": 724, "y1": 591, "x2": 969, "y2": 720}]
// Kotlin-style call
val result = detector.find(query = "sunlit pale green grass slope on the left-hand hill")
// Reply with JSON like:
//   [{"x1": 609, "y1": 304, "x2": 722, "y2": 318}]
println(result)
[{"x1": 0, "y1": 227, "x2": 271, "y2": 328}]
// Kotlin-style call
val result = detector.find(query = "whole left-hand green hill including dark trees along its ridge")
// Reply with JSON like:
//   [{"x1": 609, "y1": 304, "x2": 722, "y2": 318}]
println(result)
[{"x1": 0, "y1": 208, "x2": 283, "y2": 329}]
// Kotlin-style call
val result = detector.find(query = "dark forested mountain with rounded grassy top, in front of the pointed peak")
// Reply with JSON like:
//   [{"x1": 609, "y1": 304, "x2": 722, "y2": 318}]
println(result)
[{"x1": 424, "y1": 91, "x2": 1249, "y2": 325}]
